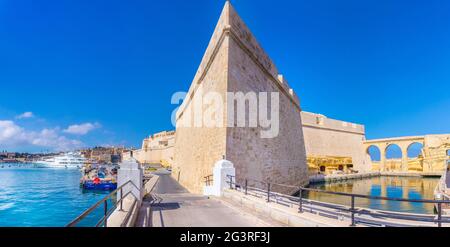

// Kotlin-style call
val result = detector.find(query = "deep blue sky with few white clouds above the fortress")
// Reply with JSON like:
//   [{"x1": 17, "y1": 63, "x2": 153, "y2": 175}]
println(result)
[{"x1": 0, "y1": 0, "x2": 450, "y2": 151}]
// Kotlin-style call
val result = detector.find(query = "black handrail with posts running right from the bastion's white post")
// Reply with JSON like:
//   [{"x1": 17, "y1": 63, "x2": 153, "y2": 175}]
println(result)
[{"x1": 227, "y1": 175, "x2": 450, "y2": 227}]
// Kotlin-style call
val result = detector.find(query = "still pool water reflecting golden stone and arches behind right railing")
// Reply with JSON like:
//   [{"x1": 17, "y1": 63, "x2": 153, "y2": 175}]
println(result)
[{"x1": 306, "y1": 177, "x2": 439, "y2": 214}]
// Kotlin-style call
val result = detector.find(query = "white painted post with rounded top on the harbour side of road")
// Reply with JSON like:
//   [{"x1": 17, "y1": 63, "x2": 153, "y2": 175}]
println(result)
[{"x1": 117, "y1": 157, "x2": 144, "y2": 201}]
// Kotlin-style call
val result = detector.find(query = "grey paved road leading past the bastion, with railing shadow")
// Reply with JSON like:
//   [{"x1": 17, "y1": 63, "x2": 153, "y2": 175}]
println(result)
[{"x1": 145, "y1": 170, "x2": 284, "y2": 227}]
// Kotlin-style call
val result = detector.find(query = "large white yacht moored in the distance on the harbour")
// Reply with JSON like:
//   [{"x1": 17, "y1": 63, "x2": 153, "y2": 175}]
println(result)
[{"x1": 35, "y1": 153, "x2": 87, "y2": 169}]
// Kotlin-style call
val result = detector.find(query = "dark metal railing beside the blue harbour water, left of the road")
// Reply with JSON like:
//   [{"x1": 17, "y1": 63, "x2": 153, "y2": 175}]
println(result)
[{"x1": 66, "y1": 180, "x2": 137, "y2": 227}]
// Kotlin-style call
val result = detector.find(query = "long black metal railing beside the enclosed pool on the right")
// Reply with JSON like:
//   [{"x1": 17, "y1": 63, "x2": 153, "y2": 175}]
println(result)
[{"x1": 227, "y1": 175, "x2": 450, "y2": 227}]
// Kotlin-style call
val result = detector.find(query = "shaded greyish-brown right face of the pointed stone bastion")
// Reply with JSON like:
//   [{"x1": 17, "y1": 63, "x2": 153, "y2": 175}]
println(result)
[{"x1": 227, "y1": 29, "x2": 308, "y2": 193}]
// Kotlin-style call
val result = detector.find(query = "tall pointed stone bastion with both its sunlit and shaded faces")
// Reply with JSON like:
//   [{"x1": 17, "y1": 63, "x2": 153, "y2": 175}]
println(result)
[{"x1": 173, "y1": 2, "x2": 308, "y2": 193}]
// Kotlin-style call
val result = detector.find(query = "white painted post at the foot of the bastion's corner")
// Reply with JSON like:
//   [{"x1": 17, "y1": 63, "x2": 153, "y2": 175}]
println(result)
[{"x1": 204, "y1": 160, "x2": 236, "y2": 196}]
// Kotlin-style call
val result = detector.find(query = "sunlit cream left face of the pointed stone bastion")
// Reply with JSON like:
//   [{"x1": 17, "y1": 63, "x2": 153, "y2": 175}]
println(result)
[{"x1": 172, "y1": 34, "x2": 228, "y2": 193}]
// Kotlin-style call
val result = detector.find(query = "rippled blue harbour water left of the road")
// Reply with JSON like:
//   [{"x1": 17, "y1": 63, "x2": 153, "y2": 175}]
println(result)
[{"x1": 0, "y1": 164, "x2": 112, "y2": 227}]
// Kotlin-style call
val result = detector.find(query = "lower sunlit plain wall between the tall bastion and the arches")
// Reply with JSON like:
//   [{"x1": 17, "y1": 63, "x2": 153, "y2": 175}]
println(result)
[{"x1": 302, "y1": 112, "x2": 371, "y2": 172}]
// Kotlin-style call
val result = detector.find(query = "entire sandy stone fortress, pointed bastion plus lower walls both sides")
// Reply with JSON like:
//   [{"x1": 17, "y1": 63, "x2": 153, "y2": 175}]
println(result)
[{"x1": 124, "y1": 1, "x2": 450, "y2": 193}]
